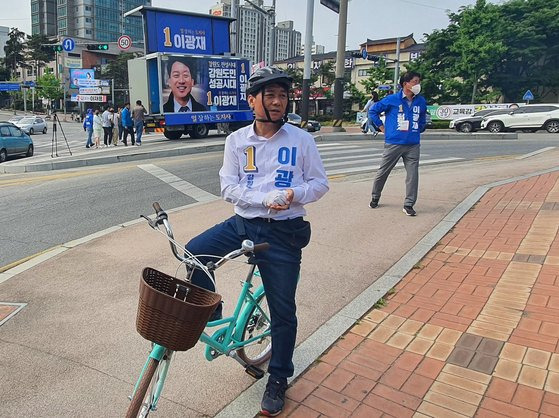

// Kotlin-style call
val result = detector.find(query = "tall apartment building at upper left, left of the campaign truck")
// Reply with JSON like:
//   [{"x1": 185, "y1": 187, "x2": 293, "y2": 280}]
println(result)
[{"x1": 31, "y1": 0, "x2": 151, "y2": 42}]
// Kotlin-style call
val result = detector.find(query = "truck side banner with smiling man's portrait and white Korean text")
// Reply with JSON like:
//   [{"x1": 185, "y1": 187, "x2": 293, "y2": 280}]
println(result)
[{"x1": 160, "y1": 55, "x2": 251, "y2": 116}]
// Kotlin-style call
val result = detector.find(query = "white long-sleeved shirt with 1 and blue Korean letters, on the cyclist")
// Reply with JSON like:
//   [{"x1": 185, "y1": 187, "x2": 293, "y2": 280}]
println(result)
[{"x1": 219, "y1": 124, "x2": 329, "y2": 220}]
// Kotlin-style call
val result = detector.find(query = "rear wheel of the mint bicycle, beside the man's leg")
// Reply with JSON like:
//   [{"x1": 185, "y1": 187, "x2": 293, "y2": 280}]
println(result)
[{"x1": 237, "y1": 293, "x2": 272, "y2": 366}]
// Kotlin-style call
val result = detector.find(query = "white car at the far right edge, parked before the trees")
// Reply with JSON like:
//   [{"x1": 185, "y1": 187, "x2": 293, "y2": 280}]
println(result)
[{"x1": 481, "y1": 104, "x2": 559, "y2": 133}]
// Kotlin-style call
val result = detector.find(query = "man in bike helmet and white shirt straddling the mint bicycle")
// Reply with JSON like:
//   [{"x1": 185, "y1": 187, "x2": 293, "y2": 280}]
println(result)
[{"x1": 186, "y1": 67, "x2": 329, "y2": 416}]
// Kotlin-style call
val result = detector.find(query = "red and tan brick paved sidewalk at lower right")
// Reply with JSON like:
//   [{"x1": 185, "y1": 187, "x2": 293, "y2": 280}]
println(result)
[{"x1": 282, "y1": 172, "x2": 559, "y2": 418}]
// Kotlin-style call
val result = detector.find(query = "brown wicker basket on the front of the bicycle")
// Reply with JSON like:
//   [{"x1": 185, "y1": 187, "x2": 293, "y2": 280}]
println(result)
[{"x1": 136, "y1": 267, "x2": 221, "y2": 351}]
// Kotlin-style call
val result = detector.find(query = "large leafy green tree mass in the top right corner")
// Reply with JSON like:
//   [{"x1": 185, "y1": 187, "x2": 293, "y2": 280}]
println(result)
[{"x1": 407, "y1": 0, "x2": 559, "y2": 104}]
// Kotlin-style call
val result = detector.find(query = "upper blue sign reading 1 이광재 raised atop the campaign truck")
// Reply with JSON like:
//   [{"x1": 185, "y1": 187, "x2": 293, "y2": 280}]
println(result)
[{"x1": 144, "y1": 10, "x2": 230, "y2": 55}]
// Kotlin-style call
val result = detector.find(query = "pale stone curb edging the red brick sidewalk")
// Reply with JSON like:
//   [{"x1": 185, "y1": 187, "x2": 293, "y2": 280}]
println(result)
[{"x1": 216, "y1": 166, "x2": 559, "y2": 418}]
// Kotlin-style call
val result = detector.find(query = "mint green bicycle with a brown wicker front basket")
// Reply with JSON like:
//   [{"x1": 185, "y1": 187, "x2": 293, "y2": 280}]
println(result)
[{"x1": 126, "y1": 202, "x2": 272, "y2": 418}]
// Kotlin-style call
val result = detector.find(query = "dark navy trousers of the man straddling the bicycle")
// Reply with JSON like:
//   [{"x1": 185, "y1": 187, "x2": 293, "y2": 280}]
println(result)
[{"x1": 186, "y1": 215, "x2": 311, "y2": 378}]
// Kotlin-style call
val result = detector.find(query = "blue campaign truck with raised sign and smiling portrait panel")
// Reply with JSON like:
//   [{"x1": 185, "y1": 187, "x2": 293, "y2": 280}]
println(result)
[{"x1": 125, "y1": 6, "x2": 253, "y2": 139}]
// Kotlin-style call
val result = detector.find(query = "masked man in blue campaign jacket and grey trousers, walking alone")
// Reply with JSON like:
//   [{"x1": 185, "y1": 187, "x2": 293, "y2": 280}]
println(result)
[{"x1": 369, "y1": 71, "x2": 427, "y2": 216}]
